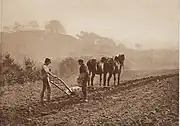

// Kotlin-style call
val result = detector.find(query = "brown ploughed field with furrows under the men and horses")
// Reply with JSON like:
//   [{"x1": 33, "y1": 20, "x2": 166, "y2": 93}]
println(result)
[{"x1": 0, "y1": 70, "x2": 179, "y2": 126}]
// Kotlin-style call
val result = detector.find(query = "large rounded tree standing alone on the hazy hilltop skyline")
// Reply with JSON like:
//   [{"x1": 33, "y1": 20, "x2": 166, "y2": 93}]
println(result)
[{"x1": 45, "y1": 20, "x2": 66, "y2": 33}]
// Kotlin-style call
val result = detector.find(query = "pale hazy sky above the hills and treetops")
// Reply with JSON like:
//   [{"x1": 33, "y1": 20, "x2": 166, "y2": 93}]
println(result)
[{"x1": 1, "y1": 0, "x2": 179, "y2": 47}]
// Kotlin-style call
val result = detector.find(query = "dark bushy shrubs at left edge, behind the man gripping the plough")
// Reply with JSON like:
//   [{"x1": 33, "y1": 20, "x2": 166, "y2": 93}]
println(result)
[{"x1": 0, "y1": 53, "x2": 40, "y2": 86}]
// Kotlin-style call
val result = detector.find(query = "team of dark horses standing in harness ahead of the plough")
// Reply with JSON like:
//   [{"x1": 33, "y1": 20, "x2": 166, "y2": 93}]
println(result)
[{"x1": 87, "y1": 54, "x2": 125, "y2": 87}]
